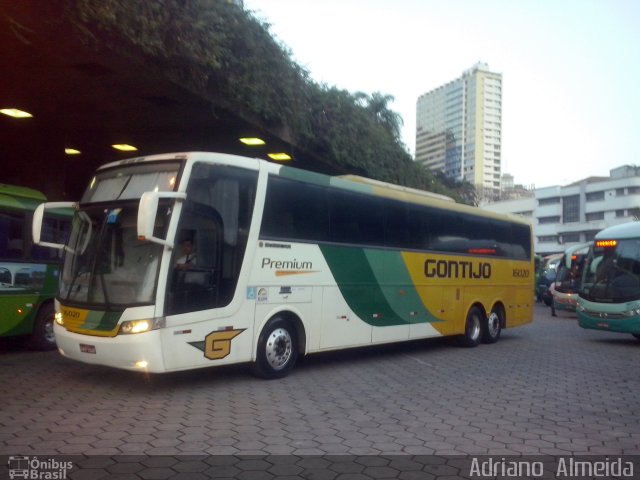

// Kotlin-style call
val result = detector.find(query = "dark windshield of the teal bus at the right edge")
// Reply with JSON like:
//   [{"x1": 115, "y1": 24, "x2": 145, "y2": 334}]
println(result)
[{"x1": 580, "y1": 239, "x2": 640, "y2": 303}]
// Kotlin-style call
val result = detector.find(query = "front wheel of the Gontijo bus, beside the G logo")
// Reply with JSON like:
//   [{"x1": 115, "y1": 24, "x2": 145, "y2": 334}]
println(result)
[{"x1": 252, "y1": 317, "x2": 298, "y2": 379}]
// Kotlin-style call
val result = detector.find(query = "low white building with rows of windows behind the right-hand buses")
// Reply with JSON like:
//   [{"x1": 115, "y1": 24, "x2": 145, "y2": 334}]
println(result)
[{"x1": 481, "y1": 165, "x2": 640, "y2": 255}]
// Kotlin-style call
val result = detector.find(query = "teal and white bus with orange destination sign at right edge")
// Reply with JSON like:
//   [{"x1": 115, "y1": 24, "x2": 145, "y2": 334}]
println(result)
[{"x1": 577, "y1": 222, "x2": 640, "y2": 339}]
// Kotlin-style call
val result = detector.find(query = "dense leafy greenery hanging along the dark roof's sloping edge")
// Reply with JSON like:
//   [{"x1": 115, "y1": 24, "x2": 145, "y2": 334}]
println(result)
[{"x1": 57, "y1": 0, "x2": 463, "y2": 200}]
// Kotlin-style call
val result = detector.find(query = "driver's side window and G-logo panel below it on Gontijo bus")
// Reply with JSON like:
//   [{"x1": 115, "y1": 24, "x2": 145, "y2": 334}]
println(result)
[{"x1": 163, "y1": 163, "x2": 258, "y2": 369}]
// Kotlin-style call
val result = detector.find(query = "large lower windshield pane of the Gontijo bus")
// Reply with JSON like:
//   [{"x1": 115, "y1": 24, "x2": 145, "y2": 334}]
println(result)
[{"x1": 60, "y1": 202, "x2": 164, "y2": 310}]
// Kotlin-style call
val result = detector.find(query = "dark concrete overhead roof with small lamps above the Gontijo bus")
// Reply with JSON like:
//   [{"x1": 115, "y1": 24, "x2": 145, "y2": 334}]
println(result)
[{"x1": 0, "y1": 0, "x2": 343, "y2": 200}]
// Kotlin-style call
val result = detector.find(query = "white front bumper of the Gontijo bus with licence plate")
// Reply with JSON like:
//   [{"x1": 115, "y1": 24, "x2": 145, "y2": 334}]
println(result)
[{"x1": 54, "y1": 324, "x2": 166, "y2": 373}]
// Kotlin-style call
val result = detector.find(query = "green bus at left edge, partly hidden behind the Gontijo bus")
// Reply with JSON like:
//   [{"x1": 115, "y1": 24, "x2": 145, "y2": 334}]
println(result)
[{"x1": 0, "y1": 184, "x2": 70, "y2": 350}]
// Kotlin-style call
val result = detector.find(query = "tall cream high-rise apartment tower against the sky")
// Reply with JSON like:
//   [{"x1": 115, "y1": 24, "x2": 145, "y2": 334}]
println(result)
[{"x1": 416, "y1": 63, "x2": 502, "y2": 198}]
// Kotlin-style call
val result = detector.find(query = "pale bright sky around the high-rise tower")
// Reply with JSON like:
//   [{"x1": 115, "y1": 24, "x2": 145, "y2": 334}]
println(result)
[{"x1": 244, "y1": 0, "x2": 640, "y2": 188}]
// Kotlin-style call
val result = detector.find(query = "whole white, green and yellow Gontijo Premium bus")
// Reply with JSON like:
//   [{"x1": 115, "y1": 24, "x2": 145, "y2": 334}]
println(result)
[{"x1": 34, "y1": 152, "x2": 534, "y2": 378}]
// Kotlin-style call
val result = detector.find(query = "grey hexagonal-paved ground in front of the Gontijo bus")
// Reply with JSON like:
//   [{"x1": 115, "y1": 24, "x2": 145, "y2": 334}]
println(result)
[{"x1": 0, "y1": 306, "x2": 640, "y2": 478}]
